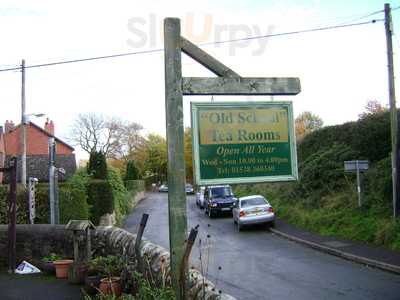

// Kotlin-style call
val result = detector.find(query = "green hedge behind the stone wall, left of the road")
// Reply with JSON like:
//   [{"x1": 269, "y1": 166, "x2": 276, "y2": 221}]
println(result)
[{"x1": 0, "y1": 168, "x2": 144, "y2": 224}]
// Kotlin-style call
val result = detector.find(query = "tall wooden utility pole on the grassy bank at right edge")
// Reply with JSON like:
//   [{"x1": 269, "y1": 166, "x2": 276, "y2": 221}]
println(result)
[{"x1": 385, "y1": 3, "x2": 400, "y2": 218}]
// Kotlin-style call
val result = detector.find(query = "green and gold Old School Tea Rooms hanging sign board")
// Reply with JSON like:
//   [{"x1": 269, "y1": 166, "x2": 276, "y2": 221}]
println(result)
[{"x1": 191, "y1": 102, "x2": 297, "y2": 185}]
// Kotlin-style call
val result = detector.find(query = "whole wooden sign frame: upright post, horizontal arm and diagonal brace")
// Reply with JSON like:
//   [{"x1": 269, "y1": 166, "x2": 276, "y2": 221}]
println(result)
[{"x1": 164, "y1": 18, "x2": 300, "y2": 300}]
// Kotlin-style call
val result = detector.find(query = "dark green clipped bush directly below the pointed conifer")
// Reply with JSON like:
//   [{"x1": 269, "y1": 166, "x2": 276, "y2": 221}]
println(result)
[{"x1": 88, "y1": 179, "x2": 115, "y2": 225}]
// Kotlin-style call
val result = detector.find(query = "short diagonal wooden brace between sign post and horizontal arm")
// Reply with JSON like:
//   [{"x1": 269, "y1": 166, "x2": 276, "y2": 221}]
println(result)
[{"x1": 181, "y1": 37, "x2": 240, "y2": 78}]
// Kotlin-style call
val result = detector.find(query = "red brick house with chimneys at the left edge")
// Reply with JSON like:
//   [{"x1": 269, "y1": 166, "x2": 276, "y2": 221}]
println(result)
[{"x1": 0, "y1": 120, "x2": 76, "y2": 183}]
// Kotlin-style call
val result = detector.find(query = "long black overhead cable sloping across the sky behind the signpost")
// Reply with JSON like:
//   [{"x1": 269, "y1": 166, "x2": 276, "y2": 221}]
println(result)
[{"x1": 0, "y1": 18, "x2": 382, "y2": 72}]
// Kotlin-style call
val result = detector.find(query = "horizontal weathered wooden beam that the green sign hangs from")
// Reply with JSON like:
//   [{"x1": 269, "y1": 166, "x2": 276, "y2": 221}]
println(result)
[{"x1": 182, "y1": 77, "x2": 301, "y2": 95}]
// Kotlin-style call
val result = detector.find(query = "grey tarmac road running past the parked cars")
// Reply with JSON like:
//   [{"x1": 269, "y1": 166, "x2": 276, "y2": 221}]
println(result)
[{"x1": 124, "y1": 193, "x2": 400, "y2": 300}]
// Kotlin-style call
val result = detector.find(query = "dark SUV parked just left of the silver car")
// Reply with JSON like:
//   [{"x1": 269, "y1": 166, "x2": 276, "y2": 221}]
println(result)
[{"x1": 204, "y1": 185, "x2": 236, "y2": 218}]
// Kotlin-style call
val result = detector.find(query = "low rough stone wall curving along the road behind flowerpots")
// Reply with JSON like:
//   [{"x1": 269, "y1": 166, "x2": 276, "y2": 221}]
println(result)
[{"x1": 0, "y1": 224, "x2": 235, "y2": 300}]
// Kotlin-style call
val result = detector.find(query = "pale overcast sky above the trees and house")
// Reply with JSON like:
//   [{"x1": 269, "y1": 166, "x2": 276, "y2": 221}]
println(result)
[{"x1": 0, "y1": 0, "x2": 400, "y2": 158}]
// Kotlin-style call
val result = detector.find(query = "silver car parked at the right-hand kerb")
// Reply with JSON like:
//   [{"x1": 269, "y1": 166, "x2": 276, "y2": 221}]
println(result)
[{"x1": 232, "y1": 195, "x2": 275, "y2": 231}]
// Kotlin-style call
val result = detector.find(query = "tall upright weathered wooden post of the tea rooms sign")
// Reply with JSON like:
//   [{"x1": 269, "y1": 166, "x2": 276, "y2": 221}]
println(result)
[{"x1": 164, "y1": 18, "x2": 188, "y2": 300}]
